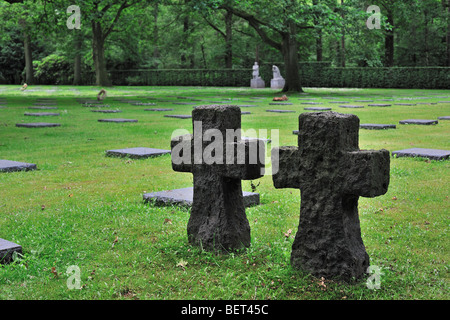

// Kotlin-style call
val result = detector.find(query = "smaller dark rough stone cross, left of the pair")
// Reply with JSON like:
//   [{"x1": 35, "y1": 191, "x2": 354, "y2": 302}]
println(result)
[{"x1": 171, "y1": 105, "x2": 265, "y2": 251}]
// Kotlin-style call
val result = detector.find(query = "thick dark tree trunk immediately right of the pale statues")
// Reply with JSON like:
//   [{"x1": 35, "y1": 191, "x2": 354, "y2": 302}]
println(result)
[{"x1": 282, "y1": 22, "x2": 303, "y2": 92}]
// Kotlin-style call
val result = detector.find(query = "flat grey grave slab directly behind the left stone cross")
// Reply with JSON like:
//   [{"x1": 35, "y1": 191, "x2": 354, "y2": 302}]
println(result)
[{"x1": 143, "y1": 187, "x2": 260, "y2": 207}]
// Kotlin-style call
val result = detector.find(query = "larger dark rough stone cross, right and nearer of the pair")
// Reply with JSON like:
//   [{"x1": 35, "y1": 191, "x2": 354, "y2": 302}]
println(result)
[{"x1": 272, "y1": 111, "x2": 390, "y2": 280}]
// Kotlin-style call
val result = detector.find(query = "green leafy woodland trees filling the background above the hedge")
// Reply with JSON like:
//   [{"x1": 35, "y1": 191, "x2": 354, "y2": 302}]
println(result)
[{"x1": 0, "y1": 0, "x2": 450, "y2": 92}]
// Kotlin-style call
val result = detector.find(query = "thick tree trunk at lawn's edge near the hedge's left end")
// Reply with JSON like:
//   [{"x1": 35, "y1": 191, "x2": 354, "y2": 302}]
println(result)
[{"x1": 92, "y1": 21, "x2": 111, "y2": 87}]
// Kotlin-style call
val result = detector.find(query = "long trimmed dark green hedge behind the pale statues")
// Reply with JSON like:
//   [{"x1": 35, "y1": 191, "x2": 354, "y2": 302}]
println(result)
[{"x1": 110, "y1": 63, "x2": 450, "y2": 89}]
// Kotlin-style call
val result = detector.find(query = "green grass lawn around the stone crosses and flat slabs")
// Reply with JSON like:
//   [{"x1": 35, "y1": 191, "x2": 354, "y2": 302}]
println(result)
[{"x1": 0, "y1": 86, "x2": 450, "y2": 300}]
